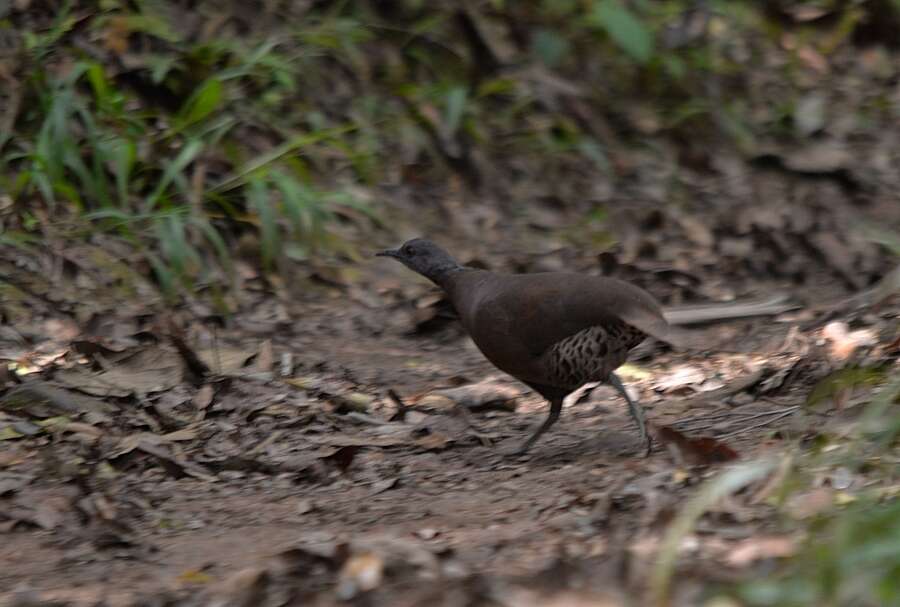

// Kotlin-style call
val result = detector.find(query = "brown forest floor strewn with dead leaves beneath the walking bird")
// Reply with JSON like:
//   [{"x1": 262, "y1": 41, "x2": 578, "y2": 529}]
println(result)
[{"x1": 0, "y1": 172, "x2": 900, "y2": 606}]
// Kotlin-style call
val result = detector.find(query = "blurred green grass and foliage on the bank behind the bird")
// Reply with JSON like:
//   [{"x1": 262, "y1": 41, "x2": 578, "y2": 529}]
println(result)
[{"x1": 0, "y1": 0, "x2": 900, "y2": 295}]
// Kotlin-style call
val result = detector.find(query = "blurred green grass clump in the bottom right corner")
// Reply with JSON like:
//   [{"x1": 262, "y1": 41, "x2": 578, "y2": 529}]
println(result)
[{"x1": 739, "y1": 376, "x2": 900, "y2": 606}]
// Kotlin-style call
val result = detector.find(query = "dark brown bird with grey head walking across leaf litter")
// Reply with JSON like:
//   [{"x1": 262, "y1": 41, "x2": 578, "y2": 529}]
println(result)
[{"x1": 375, "y1": 238, "x2": 668, "y2": 455}]
